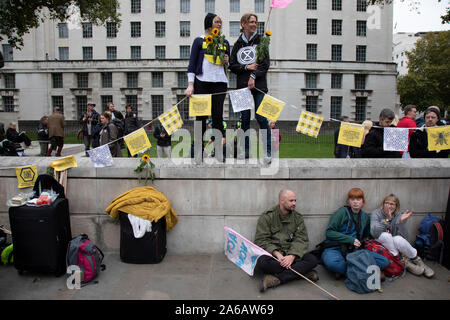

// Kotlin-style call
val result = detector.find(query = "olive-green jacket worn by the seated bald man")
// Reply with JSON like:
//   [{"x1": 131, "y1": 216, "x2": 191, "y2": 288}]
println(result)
[{"x1": 255, "y1": 205, "x2": 309, "y2": 259}]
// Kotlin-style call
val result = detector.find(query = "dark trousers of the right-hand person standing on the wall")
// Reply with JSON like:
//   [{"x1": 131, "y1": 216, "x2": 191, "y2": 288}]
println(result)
[{"x1": 241, "y1": 91, "x2": 272, "y2": 158}]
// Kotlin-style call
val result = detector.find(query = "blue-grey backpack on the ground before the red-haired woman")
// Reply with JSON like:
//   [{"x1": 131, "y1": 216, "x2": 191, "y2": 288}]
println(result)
[{"x1": 345, "y1": 249, "x2": 377, "y2": 293}]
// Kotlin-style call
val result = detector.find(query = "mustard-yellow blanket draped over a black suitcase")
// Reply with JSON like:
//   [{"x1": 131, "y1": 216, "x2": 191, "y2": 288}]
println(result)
[{"x1": 105, "y1": 187, "x2": 178, "y2": 231}]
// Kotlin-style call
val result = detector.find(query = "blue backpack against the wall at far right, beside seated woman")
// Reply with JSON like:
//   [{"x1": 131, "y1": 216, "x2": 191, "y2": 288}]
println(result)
[{"x1": 413, "y1": 214, "x2": 444, "y2": 263}]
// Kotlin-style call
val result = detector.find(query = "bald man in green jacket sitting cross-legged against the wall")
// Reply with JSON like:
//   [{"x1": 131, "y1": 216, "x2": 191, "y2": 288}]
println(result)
[{"x1": 255, "y1": 189, "x2": 319, "y2": 292}]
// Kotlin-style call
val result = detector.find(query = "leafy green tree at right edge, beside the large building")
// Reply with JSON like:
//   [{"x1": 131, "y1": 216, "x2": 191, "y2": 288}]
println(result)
[{"x1": 397, "y1": 31, "x2": 450, "y2": 111}]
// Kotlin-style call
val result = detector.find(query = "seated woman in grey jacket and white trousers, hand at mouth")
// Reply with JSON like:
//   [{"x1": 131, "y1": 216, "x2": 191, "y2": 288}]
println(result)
[{"x1": 370, "y1": 194, "x2": 434, "y2": 278}]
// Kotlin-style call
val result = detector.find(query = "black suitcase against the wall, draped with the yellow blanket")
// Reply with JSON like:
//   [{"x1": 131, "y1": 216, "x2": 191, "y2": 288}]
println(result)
[{"x1": 119, "y1": 212, "x2": 167, "y2": 264}]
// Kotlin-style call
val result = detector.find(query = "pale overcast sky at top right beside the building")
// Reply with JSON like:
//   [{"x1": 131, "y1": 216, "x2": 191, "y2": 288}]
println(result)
[{"x1": 394, "y1": 0, "x2": 450, "y2": 33}]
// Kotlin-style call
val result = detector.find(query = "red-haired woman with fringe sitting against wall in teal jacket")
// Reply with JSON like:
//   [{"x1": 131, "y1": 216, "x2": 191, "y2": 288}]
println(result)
[{"x1": 322, "y1": 188, "x2": 389, "y2": 278}]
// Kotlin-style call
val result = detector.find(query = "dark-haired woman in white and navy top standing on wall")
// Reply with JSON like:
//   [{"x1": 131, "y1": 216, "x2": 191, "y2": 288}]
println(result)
[{"x1": 185, "y1": 13, "x2": 230, "y2": 162}]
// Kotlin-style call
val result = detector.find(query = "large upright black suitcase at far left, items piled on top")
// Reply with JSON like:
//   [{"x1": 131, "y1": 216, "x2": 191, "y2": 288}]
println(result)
[{"x1": 9, "y1": 175, "x2": 72, "y2": 276}]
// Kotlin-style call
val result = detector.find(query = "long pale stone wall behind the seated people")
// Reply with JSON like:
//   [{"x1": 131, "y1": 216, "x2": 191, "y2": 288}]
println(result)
[{"x1": 0, "y1": 157, "x2": 450, "y2": 254}]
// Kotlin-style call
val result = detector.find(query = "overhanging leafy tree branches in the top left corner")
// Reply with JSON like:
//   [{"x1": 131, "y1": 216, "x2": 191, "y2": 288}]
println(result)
[{"x1": 0, "y1": 0, "x2": 120, "y2": 49}]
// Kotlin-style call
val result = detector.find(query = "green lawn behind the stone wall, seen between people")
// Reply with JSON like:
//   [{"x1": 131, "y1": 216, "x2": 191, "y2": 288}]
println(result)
[{"x1": 24, "y1": 134, "x2": 334, "y2": 158}]
